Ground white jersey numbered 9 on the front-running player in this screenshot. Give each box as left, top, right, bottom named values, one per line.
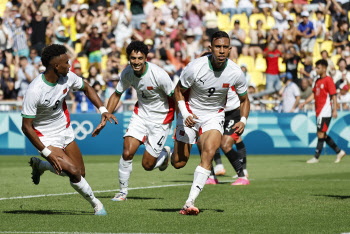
left=180, top=55, right=247, bottom=117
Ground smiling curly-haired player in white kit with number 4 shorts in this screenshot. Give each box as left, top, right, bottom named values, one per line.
left=92, top=41, right=175, bottom=201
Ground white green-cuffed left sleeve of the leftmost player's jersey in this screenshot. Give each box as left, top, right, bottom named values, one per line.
left=21, top=89, right=40, bottom=119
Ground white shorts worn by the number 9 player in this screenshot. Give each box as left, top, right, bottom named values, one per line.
left=176, top=111, right=225, bottom=145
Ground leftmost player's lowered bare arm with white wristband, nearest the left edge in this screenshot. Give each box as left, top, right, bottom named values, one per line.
left=22, top=118, right=62, bottom=175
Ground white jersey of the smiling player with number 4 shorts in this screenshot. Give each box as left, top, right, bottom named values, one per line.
left=115, top=62, right=175, bottom=124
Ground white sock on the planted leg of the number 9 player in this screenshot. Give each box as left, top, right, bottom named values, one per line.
left=186, top=166, right=210, bottom=203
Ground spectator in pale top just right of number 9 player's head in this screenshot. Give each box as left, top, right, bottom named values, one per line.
left=228, top=20, right=246, bottom=61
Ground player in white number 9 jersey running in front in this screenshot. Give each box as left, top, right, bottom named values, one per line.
left=171, top=31, right=250, bottom=215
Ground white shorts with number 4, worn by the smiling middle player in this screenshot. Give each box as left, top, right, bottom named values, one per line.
left=124, top=113, right=171, bottom=158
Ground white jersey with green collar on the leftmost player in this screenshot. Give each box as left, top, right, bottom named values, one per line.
left=22, top=71, right=84, bottom=137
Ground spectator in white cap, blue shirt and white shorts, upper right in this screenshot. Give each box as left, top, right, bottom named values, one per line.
left=298, top=11, right=316, bottom=55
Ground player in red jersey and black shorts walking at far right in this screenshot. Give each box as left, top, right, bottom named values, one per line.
left=299, top=59, right=345, bottom=163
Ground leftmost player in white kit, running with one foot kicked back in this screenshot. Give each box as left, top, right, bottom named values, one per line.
left=22, top=44, right=117, bottom=215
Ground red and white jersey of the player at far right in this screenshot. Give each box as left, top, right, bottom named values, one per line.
left=312, top=76, right=337, bottom=117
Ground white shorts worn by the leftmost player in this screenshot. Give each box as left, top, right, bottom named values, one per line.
left=39, top=125, right=75, bottom=149
